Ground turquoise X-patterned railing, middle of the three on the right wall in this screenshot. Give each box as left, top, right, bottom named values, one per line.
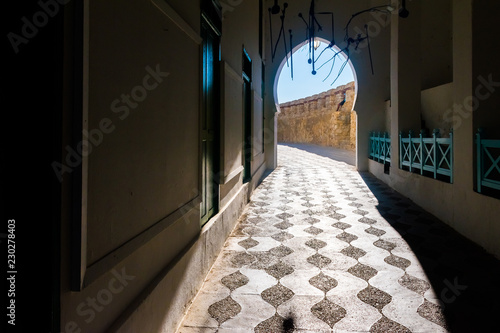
left=399, top=130, right=453, bottom=183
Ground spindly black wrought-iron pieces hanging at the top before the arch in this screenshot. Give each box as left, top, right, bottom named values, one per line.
left=269, top=0, right=409, bottom=85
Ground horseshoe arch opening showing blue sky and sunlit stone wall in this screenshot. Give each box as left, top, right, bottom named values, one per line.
left=274, top=38, right=358, bottom=164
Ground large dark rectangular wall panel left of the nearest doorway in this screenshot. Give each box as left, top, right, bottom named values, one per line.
left=87, top=0, right=201, bottom=264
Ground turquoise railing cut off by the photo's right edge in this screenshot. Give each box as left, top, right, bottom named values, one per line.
left=476, top=129, right=500, bottom=193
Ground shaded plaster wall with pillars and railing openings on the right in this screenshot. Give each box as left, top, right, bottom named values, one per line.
left=368, top=0, right=500, bottom=257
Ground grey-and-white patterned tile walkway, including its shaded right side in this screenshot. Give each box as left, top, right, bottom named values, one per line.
left=178, top=146, right=500, bottom=333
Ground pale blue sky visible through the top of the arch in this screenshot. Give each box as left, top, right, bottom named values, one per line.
left=277, top=42, right=354, bottom=104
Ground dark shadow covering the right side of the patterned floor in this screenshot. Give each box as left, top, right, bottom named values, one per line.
left=360, top=172, right=500, bottom=333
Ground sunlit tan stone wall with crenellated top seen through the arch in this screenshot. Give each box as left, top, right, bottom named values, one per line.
left=278, top=82, right=356, bottom=151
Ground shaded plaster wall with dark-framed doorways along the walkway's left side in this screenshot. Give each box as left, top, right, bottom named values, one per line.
left=60, top=0, right=265, bottom=333
